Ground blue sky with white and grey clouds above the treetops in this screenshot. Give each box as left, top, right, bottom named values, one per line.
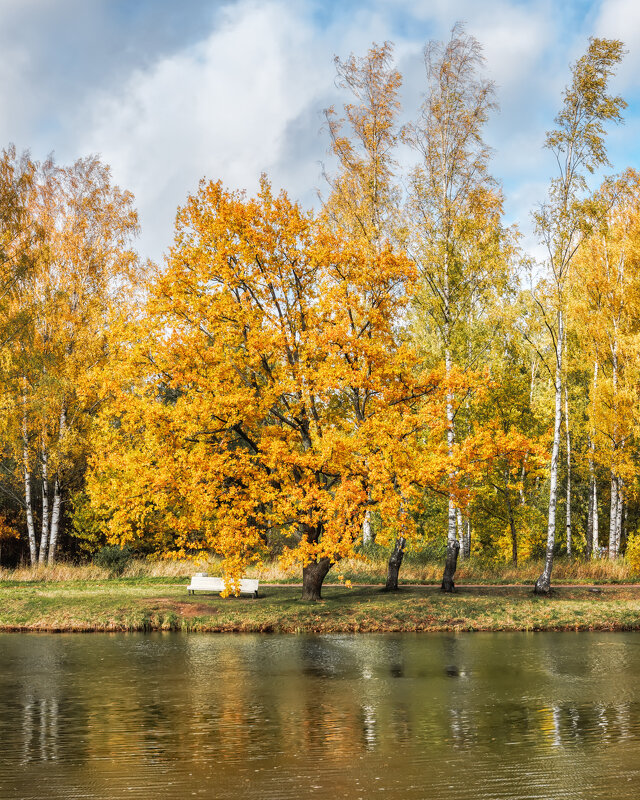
left=0, top=0, right=640, bottom=260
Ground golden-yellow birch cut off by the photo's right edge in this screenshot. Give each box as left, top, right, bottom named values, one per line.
left=570, top=169, right=640, bottom=558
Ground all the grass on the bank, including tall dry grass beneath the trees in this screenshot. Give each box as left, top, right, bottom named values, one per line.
left=0, top=558, right=640, bottom=633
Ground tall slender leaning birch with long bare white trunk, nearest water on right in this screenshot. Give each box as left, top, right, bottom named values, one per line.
left=534, top=38, right=625, bottom=594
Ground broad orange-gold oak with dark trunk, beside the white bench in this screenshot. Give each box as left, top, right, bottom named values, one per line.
left=90, top=179, right=442, bottom=600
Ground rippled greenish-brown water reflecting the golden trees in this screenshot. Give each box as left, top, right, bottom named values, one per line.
left=0, top=633, right=640, bottom=800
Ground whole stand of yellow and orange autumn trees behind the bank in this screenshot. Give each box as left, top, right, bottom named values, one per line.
left=0, top=24, right=640, bottom=600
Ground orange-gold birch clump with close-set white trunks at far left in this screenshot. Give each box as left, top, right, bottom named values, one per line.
left=3, top=158, right=137, bottom=564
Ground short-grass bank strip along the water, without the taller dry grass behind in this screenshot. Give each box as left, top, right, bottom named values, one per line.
left=0, top=578, right=640, bottom=633
